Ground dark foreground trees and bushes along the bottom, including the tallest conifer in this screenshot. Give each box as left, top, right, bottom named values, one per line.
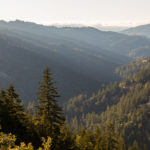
left=0, top=68, right=138, bottom=150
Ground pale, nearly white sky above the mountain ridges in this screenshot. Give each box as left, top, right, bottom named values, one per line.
left=0, top=0, right=150, bottom=25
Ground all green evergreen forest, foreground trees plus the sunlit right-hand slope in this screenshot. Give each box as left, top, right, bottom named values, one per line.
left=0, top=57, right=150, bottom=150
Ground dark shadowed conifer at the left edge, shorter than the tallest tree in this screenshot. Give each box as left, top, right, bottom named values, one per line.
left=0, top=84, right=30, bottom=142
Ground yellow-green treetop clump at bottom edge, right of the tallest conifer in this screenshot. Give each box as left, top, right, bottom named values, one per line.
left=76, top=123, right=125, bottom=150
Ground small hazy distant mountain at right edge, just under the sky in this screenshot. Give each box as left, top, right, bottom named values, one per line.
left=121, top=24, right=150, bottom=38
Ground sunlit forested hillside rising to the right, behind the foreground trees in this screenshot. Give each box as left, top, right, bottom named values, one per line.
left=64, top=57, right=150, bottom=150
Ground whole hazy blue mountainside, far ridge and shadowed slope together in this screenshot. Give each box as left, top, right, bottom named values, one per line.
left=0, top=20, right=150, bottom=103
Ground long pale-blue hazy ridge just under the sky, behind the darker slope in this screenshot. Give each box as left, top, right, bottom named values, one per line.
left=0, top=20, right=150, bottom=55
